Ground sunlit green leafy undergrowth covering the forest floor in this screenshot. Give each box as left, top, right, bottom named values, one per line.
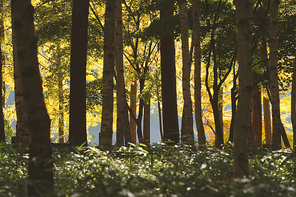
left=0, top=144, right=296, bottom=197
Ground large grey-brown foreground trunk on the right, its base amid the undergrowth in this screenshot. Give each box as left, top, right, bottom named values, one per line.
left=234, top=0, right=253, bottom=178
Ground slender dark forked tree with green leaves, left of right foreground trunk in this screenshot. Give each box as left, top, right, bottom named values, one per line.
left=202, top=0, right=237, bottom=148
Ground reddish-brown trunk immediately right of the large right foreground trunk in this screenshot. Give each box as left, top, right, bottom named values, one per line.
left=252, top=84, right=262, bottom=148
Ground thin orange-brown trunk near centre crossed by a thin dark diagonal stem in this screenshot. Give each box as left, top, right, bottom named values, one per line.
left=130, top=80, right=137, bottom=144
